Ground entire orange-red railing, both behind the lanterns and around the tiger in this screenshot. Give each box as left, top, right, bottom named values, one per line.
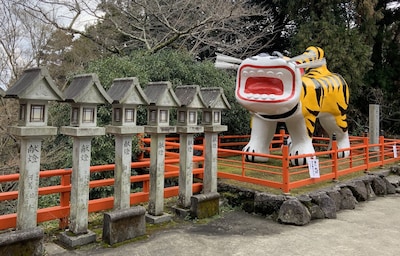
left=0, top=132, right=400, bottom=230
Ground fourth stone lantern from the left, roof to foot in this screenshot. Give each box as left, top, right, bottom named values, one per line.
left=144, top=82, right=181, bottom=223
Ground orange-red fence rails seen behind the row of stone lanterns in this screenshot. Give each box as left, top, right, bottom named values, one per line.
left=0, top=157, right=203, bottom=230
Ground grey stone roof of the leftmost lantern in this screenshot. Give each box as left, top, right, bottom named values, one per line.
left=5, top=67, right=64, bottom=101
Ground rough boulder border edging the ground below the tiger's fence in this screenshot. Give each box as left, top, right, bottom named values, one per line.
left=218, top=165, right=400, bottom=226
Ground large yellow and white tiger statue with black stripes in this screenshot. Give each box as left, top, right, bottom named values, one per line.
left=215, top=46, right=350, bottom=165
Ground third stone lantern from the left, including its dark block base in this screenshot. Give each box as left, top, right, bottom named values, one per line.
left=103, top=77, right=149, bottom=245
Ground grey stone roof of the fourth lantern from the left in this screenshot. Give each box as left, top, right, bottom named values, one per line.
left=144, top=81, right=181, bottom=107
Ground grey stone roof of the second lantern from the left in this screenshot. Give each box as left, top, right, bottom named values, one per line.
left=64, top=73, right=112, bottom=104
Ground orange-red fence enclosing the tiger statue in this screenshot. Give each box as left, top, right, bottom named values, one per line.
left=218, top=135, right=400, bottom=193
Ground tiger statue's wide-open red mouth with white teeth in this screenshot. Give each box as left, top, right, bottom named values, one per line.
left=236, top=65, right=295, bottom=103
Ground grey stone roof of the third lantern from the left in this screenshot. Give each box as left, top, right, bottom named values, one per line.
left=107, top=77, right=150, bottom=105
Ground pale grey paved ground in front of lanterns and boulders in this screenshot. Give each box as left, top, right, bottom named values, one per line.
left=46, top=194, right=400, bottom=256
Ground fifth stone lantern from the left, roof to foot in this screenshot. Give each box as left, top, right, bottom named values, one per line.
left=175, top=85, right=206, bottom=209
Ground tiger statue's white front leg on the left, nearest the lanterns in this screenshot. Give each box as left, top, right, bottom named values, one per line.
left=243, top=115, right=277, bottom=162
